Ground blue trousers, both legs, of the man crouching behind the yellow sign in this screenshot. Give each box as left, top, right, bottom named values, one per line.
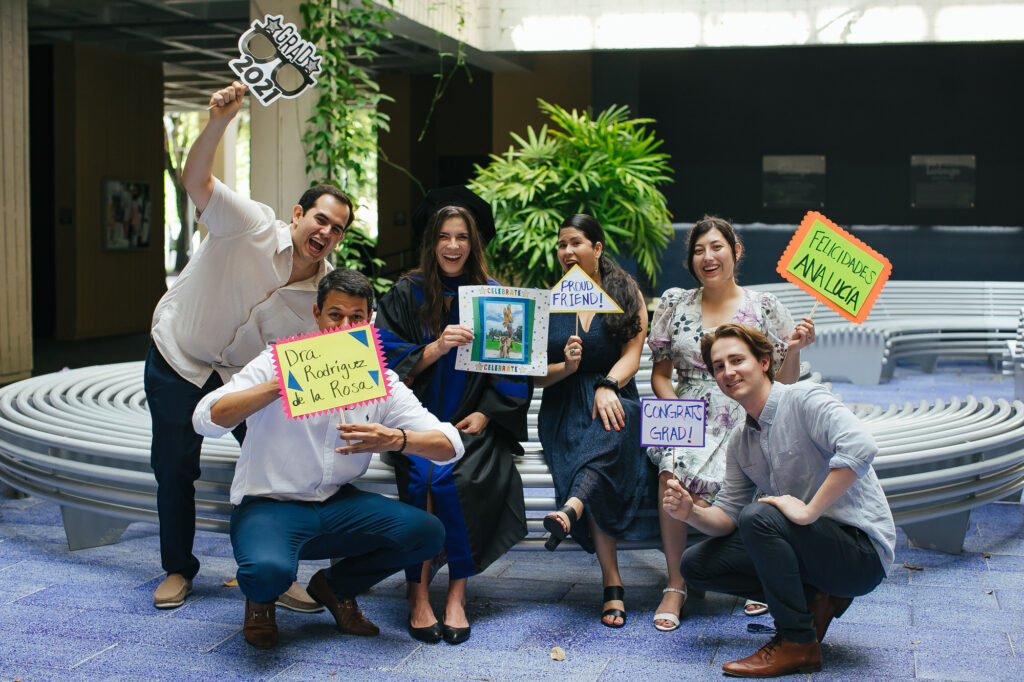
left=231, top=484, right=444, bottom=603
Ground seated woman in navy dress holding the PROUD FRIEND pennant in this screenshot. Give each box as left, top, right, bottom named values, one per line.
left=537, top=214, right=657, bottom=628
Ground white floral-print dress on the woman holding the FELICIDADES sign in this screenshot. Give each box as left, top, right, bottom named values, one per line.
left=647, top=288, right=794, bottom=503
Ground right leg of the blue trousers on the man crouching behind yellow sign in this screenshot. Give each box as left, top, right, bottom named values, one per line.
left=301, top=485, right=444, bottom=599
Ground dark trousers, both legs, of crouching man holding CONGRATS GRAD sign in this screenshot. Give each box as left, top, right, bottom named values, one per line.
left=682, top=502, right=885, bottom=642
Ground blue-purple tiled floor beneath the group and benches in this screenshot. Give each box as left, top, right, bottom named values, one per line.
left=0, top=356, right=1024, bottom=682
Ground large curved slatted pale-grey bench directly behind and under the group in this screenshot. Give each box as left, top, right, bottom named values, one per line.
left=0, top=360, right=1024, bottom=552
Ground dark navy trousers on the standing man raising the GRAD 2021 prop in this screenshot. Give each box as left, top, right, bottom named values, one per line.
left=144, top=343, right=246, bottom=580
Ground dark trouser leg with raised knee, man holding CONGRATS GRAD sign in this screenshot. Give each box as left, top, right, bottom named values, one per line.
left=738, top=502, right=885, bottom=642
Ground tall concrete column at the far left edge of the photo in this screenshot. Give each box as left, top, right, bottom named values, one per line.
left=0, top=0, right=32, bottom=384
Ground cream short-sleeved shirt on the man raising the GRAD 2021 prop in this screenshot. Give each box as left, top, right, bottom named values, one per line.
left=152, top=178, right=333, bottom=386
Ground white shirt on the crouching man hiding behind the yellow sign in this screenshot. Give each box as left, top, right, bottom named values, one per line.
left=193, top=348, right=466, bottom=505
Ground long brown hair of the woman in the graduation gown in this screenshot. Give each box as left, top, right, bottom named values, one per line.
left=407, top=206, right=490, bottom=338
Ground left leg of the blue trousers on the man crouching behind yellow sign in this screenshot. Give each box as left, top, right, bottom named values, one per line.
left=230, top=497, right=321, bottom=603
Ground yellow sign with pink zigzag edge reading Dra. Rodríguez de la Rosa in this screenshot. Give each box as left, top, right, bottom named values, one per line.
left=273, top=324, right=391, bottom=419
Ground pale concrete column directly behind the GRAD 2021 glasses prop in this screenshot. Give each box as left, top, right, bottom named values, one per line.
left=249, top=0, right=316, bottom=216
